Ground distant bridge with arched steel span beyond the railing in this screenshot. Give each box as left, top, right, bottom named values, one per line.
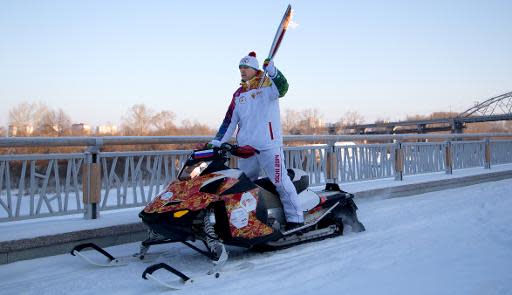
left=340, top=91, right=512, bottom=134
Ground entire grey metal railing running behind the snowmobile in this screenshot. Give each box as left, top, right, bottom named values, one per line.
left=0, top=134, right=512, bottom=222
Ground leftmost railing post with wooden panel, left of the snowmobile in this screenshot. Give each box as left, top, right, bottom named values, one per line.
left=82, top=147, right=101, bottom=219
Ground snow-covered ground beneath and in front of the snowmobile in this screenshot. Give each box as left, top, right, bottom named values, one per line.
left=0, top=179, right=512, bottom=295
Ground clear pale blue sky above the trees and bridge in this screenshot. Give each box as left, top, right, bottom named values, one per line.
left=0, top=0, right=512, bottom=128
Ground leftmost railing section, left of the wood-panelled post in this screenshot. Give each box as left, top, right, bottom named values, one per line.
left=0, top=154, right=86, bottom=221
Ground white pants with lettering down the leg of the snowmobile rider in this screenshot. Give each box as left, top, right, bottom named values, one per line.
left=238, top=148, right=304, bottom=222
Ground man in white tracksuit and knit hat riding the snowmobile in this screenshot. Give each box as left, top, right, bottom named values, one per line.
left=211, top=52, right=304, bottom=230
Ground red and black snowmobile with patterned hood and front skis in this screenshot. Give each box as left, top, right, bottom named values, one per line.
left=71, top=143, right=365, bottom=289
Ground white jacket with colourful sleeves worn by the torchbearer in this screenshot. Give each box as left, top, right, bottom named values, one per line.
left=215, top=70, right=288, bottom=150
